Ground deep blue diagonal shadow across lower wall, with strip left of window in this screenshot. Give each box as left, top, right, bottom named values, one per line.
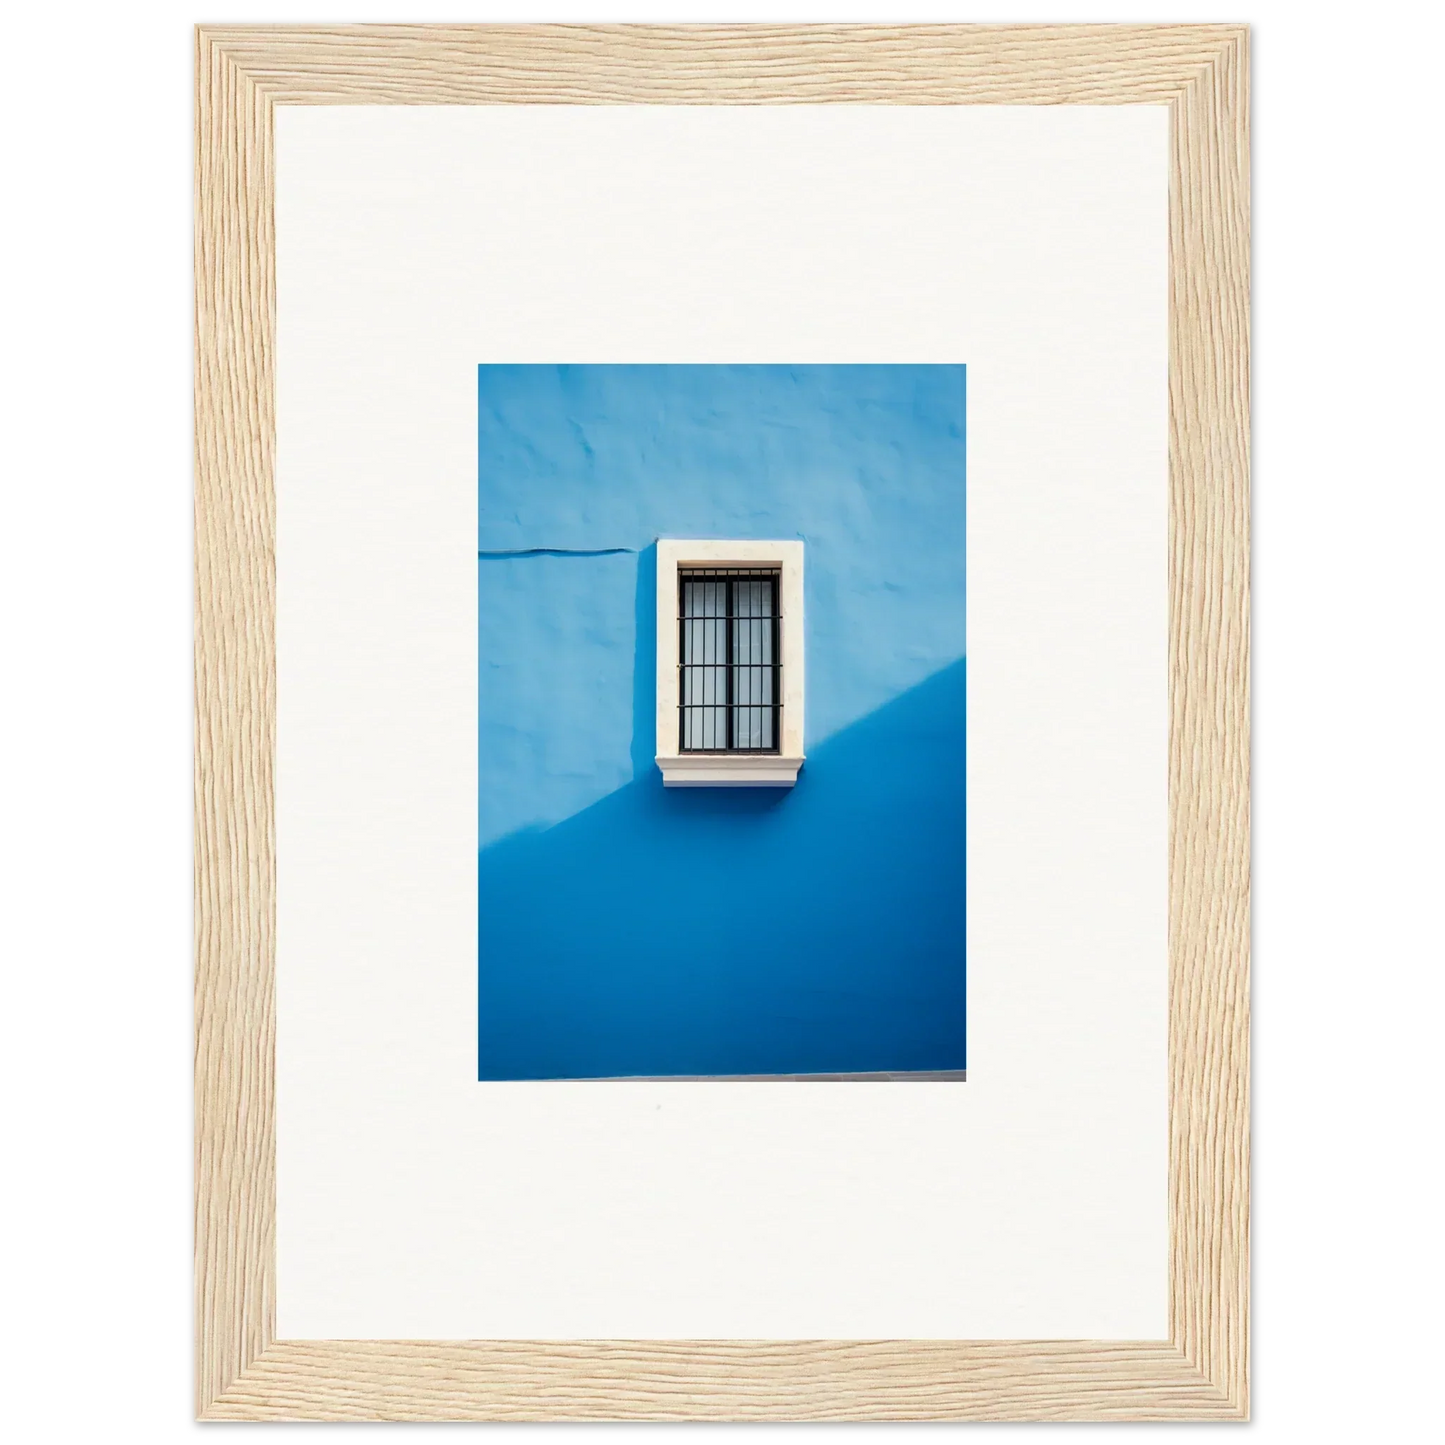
left=478, top=653, right=967, bottom=1079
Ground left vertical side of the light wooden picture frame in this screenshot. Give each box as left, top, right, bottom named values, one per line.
left=194, top=22, right=276, bottom=1421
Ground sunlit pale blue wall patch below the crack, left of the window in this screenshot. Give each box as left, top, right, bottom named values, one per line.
left=477, top=553, right=637, bottom=847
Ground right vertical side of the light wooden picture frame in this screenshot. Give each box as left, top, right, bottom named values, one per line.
left=1169, top=29, right=1250, bottom=1415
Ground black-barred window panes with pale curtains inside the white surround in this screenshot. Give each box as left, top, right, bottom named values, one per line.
left=678, top=566, right=783, bottom=753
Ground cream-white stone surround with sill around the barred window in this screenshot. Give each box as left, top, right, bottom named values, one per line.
left=657, top=539, right=803, bottom=788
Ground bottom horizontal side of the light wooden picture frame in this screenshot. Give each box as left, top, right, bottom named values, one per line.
left=208, top=1340, right=1237, bottom=1420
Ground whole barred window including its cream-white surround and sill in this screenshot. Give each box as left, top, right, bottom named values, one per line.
left=657, top=539, right=803, bottom=788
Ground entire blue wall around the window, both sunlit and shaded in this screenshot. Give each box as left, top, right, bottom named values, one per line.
left=478, top=366, right=965, bottom=1079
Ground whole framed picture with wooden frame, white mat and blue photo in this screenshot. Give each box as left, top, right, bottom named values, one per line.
left=188, top=17, right=1259, bottom=1435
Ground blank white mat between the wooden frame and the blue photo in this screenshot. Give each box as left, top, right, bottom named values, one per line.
left=276, top=105, right=1168, bottom=1340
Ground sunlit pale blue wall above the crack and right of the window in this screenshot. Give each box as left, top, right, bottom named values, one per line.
left=477, top=366, right=964, bottom=746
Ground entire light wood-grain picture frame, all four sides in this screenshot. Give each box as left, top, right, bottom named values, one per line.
left=194, top=23, right=1250, bottom=1420
